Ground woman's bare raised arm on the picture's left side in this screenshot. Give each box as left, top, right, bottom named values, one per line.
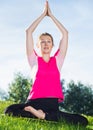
left=26, top=3, right=47, bottom=56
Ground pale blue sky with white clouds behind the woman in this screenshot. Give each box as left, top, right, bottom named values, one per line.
left=0, top=0, right=93, bottom=91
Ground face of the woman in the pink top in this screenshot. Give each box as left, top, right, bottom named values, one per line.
left=39, top=35, right=53, bottom=54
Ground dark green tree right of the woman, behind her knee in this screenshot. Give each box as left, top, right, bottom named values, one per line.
left=63, top=81, right=93, bottom=115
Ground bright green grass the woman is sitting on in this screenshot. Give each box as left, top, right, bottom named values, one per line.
left=0, top=101, right=93, bottom=130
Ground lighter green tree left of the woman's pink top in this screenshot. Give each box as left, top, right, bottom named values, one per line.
left=8, top=73, right=32, bottom=103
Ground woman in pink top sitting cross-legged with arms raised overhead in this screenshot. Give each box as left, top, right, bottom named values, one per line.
left=5, top=1, right=87, bottom=125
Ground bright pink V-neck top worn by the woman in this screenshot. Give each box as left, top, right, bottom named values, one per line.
left=28, top=51, right=64, bottom=101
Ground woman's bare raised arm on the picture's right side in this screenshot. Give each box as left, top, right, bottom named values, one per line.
left=47, top=1, right=68, bottom=57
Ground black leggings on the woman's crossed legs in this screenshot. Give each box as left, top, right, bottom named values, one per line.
left=5, top=98, right=88, bottom=126
